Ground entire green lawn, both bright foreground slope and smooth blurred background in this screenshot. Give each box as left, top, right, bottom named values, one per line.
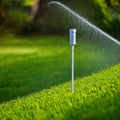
left=0, top=36, right=120, bottom=120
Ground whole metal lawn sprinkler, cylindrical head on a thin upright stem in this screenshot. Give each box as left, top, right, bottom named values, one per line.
left=69, top=29, right=76, bottom=93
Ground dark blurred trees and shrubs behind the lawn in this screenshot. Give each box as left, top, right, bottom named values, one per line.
left=0, top=0, right=120, bottom=39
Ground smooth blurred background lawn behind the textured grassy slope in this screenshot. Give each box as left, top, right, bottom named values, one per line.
left=0, top=36, right=119, bottom=102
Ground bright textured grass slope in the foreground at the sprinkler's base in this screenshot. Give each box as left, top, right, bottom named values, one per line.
left=0, top=64, right=120, bottom=120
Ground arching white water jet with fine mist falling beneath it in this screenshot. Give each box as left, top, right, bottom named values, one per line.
left=49, top=1, right=120, bottom=85
